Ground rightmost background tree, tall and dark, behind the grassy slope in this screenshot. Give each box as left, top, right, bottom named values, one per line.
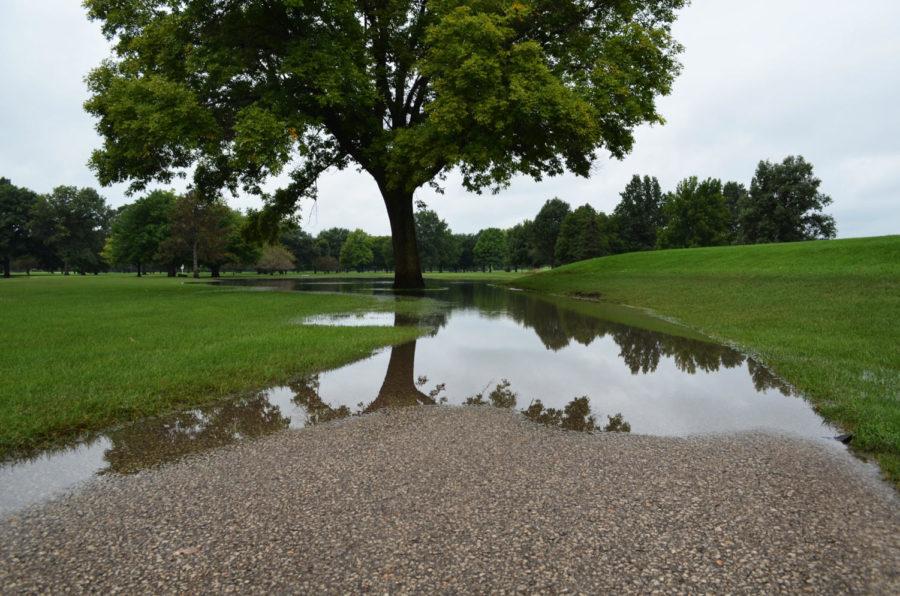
left=740, top=156, right=837, bottom=243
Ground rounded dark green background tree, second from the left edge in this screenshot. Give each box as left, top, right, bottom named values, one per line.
left=31, top=186, right=111, bottom=275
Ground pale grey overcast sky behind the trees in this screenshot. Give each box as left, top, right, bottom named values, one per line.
left=0, top=0, right=900, bottom=237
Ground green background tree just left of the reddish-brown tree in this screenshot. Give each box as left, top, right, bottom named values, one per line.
left=106, top=190, right=176, bottom=277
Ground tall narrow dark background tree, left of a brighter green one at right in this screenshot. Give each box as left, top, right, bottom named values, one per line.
left=613, top=175, right=663, bottom=252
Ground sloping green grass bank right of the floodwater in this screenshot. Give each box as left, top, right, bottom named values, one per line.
left=513, top=236, right=900, bottom=482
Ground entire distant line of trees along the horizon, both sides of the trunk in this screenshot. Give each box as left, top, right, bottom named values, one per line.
left=0, top=156, right=836, bottom=276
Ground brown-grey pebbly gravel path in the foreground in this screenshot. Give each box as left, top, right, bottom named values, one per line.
left=0, top=407, right=900, bottom=594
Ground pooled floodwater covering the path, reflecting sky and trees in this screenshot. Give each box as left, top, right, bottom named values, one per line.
left=0, top=280, right=837, bottom=515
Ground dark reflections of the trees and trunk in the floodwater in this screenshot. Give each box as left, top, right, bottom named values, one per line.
left=91, top=282, right=792, bottom=473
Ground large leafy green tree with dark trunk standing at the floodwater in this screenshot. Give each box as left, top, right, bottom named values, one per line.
left=85, top=0, right=684, bottom=287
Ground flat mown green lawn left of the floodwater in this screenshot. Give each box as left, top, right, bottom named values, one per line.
left=0, top=275, right=419, bottom=455
